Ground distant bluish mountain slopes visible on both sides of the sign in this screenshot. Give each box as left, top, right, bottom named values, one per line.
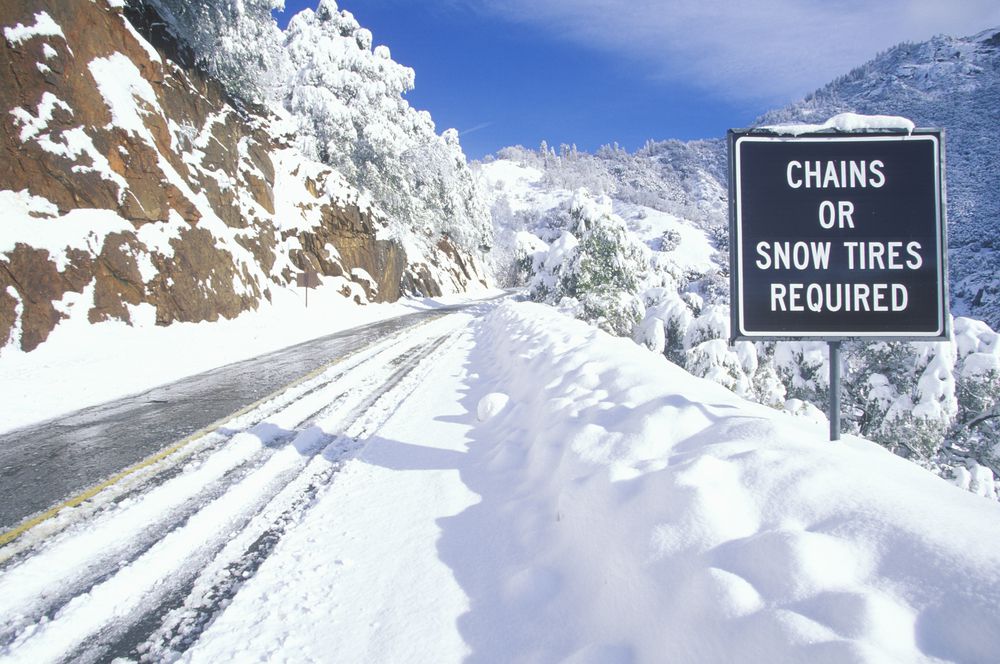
left=497, top=29, right=1000, bottom=328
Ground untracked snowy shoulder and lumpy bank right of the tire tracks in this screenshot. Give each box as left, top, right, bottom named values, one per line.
left=150, top=303, right=1000, bottom=664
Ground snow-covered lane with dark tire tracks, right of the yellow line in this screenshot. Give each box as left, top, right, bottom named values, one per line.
left=0, top=314, right=482, bottom=662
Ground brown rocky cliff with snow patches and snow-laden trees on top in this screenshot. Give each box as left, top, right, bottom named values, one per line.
left=0, top=0, right=490, bottom=354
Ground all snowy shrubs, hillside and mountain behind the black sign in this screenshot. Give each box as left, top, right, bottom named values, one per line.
left=481, top=30, right=1000, bottom=504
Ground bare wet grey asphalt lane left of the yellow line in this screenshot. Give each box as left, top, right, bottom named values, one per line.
left=0, top=305, right=469, bottom=532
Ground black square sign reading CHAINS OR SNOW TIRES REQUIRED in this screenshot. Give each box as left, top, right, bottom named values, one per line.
left=729, top=131, right=948, bottom=339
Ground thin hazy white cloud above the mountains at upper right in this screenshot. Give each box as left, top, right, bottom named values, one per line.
left=464, top=0, right=1000, bottom=102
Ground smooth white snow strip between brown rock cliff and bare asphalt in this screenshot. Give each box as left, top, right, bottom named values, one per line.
left=0, top=287, right=499, bottom=433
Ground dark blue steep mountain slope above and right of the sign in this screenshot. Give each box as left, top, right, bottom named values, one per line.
left=758, top=27, right=1000, bottom=328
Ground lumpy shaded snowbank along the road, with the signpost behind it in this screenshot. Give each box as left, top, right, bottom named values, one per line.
left=472, top=304, right=1000, bottom=663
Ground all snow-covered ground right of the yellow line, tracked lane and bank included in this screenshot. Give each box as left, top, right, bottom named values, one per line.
left=0, top=303, right=1000, bottom=664
